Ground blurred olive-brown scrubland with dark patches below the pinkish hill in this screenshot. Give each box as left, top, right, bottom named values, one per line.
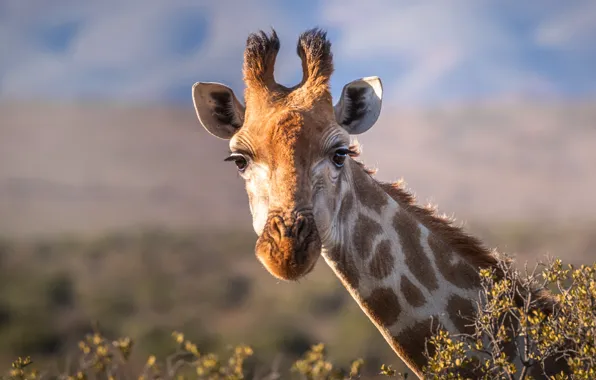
left=0, top=224, right=596, bottom=374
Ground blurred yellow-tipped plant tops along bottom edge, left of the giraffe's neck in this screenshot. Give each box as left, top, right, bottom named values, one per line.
left=0, top=331, right=408, bottom=380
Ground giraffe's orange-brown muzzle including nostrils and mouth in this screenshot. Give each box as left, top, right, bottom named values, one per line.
left=255, top=214, right=321, bottom=281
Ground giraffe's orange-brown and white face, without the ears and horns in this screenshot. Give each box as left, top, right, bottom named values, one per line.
left=230, top=108, right=349, bottom=280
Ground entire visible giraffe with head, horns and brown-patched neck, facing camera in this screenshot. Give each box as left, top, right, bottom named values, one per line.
left=192, top=28, right=568, bottom=377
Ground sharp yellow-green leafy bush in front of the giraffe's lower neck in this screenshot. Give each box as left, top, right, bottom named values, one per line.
left=426, top=260, right=596, bottom=379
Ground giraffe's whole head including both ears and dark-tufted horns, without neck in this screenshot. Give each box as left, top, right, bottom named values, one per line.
left=192, top=29, right=382, bottom=280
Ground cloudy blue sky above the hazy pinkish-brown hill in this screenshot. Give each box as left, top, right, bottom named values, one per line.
left=0, top=0, right=596, bottom=105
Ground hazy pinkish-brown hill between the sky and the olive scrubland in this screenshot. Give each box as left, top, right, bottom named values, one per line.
left=0, top=102, right=596, bottom=235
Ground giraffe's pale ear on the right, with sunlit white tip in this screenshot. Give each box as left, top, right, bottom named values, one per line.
left=335, top=77, right=383, bottom=135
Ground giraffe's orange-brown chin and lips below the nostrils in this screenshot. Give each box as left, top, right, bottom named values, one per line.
left=255, top=234, right=321, bottom=281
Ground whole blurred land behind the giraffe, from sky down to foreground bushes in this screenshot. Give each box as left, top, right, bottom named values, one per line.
left=0, top=103, right=596, bottom=378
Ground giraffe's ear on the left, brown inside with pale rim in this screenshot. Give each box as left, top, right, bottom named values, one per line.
left=192, top=82, right=244, bottom=140
